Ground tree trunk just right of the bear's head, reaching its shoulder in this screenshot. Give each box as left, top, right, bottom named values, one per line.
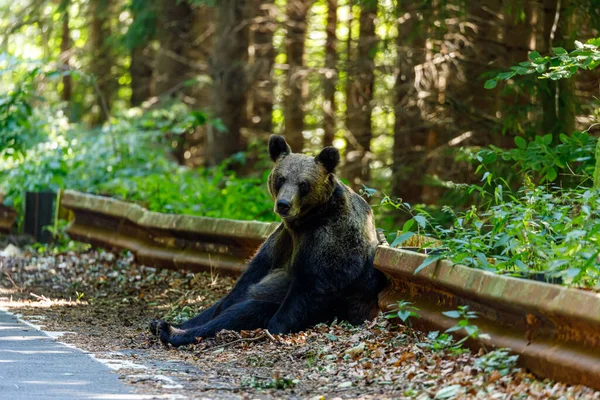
left=346, top=0, right=377, bottom=189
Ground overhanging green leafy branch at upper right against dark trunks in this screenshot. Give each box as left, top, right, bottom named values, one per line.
left=484, top=38, right=600, bottom=89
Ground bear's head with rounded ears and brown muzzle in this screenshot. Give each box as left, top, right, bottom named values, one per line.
left=269, top=135, right=340, bottom=221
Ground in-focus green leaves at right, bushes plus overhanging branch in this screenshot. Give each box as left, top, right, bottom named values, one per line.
left=376, top=39, right=600, bottom=290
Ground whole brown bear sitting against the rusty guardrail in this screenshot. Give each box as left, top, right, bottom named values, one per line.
left=150, top=135, right=385, bottom=346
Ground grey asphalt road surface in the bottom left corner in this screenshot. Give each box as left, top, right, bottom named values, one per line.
left=0, top=310, right=153, bottom=400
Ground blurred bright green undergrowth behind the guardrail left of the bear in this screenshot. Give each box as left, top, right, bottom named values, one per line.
left=0, top=100, right=274, bottom=221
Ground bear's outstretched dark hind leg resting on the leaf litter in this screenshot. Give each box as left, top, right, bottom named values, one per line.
left=157, top=300, right=279, bottom=347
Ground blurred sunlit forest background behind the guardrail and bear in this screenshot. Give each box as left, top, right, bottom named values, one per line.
left=0, top=0, right=600, bottom=230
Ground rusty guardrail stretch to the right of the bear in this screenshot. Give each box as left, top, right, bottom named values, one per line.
left=375, top=247, right=600, bottom=389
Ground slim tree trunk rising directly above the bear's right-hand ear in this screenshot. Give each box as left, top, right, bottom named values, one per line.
left=323, top=0, right=338, bottom=147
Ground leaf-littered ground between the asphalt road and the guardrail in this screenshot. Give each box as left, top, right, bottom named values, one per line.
left=0, top=242, right=600, bottom=399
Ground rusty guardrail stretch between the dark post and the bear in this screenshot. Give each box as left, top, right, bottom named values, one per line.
left=60, top=190, right=278, bottom=274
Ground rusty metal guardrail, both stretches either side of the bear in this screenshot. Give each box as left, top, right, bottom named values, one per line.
left=62, top=191, right=600, bottom=389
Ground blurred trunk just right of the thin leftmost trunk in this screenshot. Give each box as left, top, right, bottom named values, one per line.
left=89, top=0, right=115, bottom=125
